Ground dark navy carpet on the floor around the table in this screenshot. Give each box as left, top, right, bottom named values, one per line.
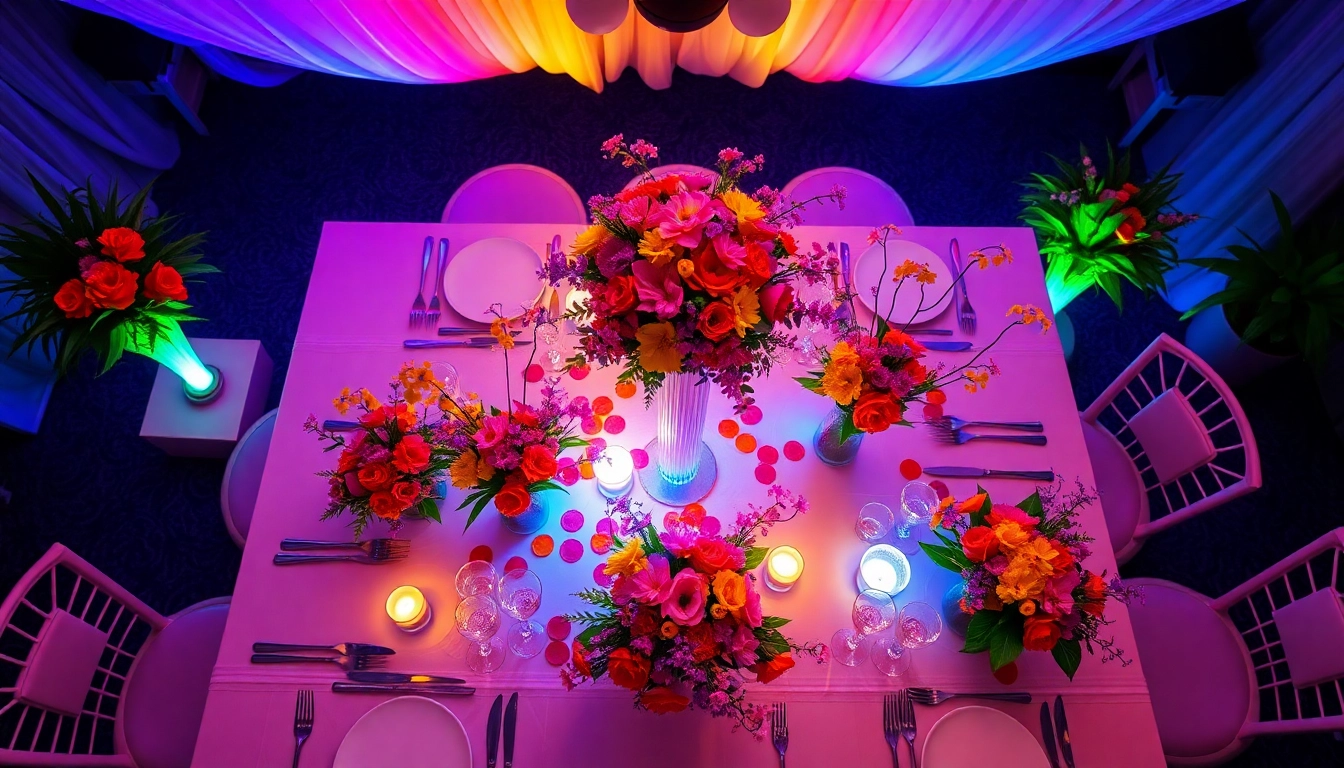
left=0, top=61, right=1344, bottom=768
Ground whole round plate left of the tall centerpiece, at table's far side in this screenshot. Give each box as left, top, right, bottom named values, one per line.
left=444, top=237, right=543, bottom=323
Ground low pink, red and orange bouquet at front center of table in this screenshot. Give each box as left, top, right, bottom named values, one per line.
left=560, top=486, right=828, bottom=737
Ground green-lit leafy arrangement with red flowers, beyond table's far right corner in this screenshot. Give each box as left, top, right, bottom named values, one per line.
left=1020, top=147, right=1199, bottom=312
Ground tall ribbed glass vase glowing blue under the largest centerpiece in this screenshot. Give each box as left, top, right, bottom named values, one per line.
left=640, top=374, right=719, bottom=507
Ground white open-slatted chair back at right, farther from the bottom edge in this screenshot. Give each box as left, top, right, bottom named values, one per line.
left=1082, top=334, right=1261, bottom=538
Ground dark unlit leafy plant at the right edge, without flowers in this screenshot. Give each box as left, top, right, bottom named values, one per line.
left=1181, top=192, right=1344, bottom=369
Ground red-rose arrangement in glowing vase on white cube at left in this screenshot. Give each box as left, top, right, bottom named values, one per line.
left=0, top=174, right=220, bottom=402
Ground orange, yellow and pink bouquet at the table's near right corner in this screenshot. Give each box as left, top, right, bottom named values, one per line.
left=919, top=484, right=1138, bottom=679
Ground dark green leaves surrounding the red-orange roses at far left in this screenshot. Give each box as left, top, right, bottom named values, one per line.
left=0, top=174, right=218, bottom=374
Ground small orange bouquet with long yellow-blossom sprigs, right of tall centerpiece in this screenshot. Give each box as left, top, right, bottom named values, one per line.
left=794, top=225, right=1051, bottom=441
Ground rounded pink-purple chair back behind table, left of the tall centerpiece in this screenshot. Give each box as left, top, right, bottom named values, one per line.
left=442, top=163, right=587, bottom=225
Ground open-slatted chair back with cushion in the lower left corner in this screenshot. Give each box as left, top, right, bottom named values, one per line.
left=0, top=543, right=168, bottom=768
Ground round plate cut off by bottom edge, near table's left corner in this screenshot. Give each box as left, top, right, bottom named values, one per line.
left=332, top=695, right=472, bottom=768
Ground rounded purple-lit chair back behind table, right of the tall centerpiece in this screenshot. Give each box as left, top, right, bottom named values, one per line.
left=784, top=165, right=915, bottom=227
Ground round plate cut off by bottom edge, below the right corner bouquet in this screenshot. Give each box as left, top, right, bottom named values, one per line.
left=919, top=706, right=1050, bottom=768
